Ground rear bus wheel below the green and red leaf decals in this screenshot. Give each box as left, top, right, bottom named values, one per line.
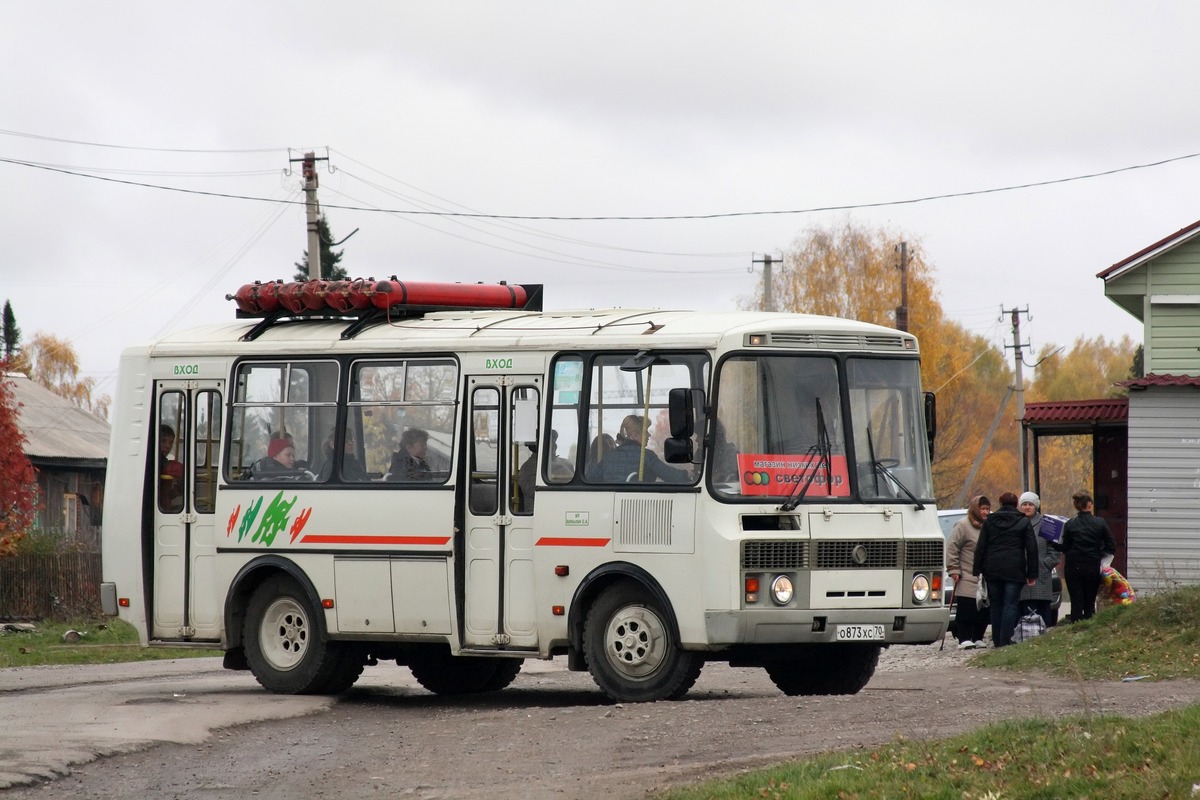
left=242, top=575, right=348, bottom=694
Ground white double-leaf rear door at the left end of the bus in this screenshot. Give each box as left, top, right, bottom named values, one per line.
left=149, top=380, right=223, bottom=642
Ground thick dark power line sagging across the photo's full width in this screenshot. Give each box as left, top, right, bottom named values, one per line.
left=0, top=152, right=1200, bottom=222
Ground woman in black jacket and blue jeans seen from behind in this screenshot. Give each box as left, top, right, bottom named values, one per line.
left=971, top=492, right=1038, bottom=648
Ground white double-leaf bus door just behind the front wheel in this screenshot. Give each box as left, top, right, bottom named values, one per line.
left=462, top=375, right=541, bottom=650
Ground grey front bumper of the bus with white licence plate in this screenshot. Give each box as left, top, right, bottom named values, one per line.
left=704, top=606, right=950, bottom=648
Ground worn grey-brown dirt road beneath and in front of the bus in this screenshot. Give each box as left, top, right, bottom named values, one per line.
left=0, top=643, right=1200, bottom=800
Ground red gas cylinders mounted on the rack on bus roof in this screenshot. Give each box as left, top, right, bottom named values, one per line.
left=226, top=276, right=542, bottom=342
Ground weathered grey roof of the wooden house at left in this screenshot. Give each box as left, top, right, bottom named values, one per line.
left=4, top=373, right=112, bottom=467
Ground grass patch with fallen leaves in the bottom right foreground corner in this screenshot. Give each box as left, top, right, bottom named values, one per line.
left=660, top=706, right=1200, bottom=800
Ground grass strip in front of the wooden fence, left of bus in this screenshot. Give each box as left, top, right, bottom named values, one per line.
left=0, top=616, right=221, bottom=668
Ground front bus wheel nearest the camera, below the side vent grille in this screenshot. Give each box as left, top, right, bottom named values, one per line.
left=583, top=583, right=703, bottom=703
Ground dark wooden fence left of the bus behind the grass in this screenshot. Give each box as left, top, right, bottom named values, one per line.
left=0, top=553, right=102, bottom=620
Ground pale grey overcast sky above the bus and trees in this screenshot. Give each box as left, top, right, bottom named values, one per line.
left=0, top=0, right=1200, bottom=393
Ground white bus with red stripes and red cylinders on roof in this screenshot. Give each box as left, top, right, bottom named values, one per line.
left=102, top=279, right=948, bottom=702
